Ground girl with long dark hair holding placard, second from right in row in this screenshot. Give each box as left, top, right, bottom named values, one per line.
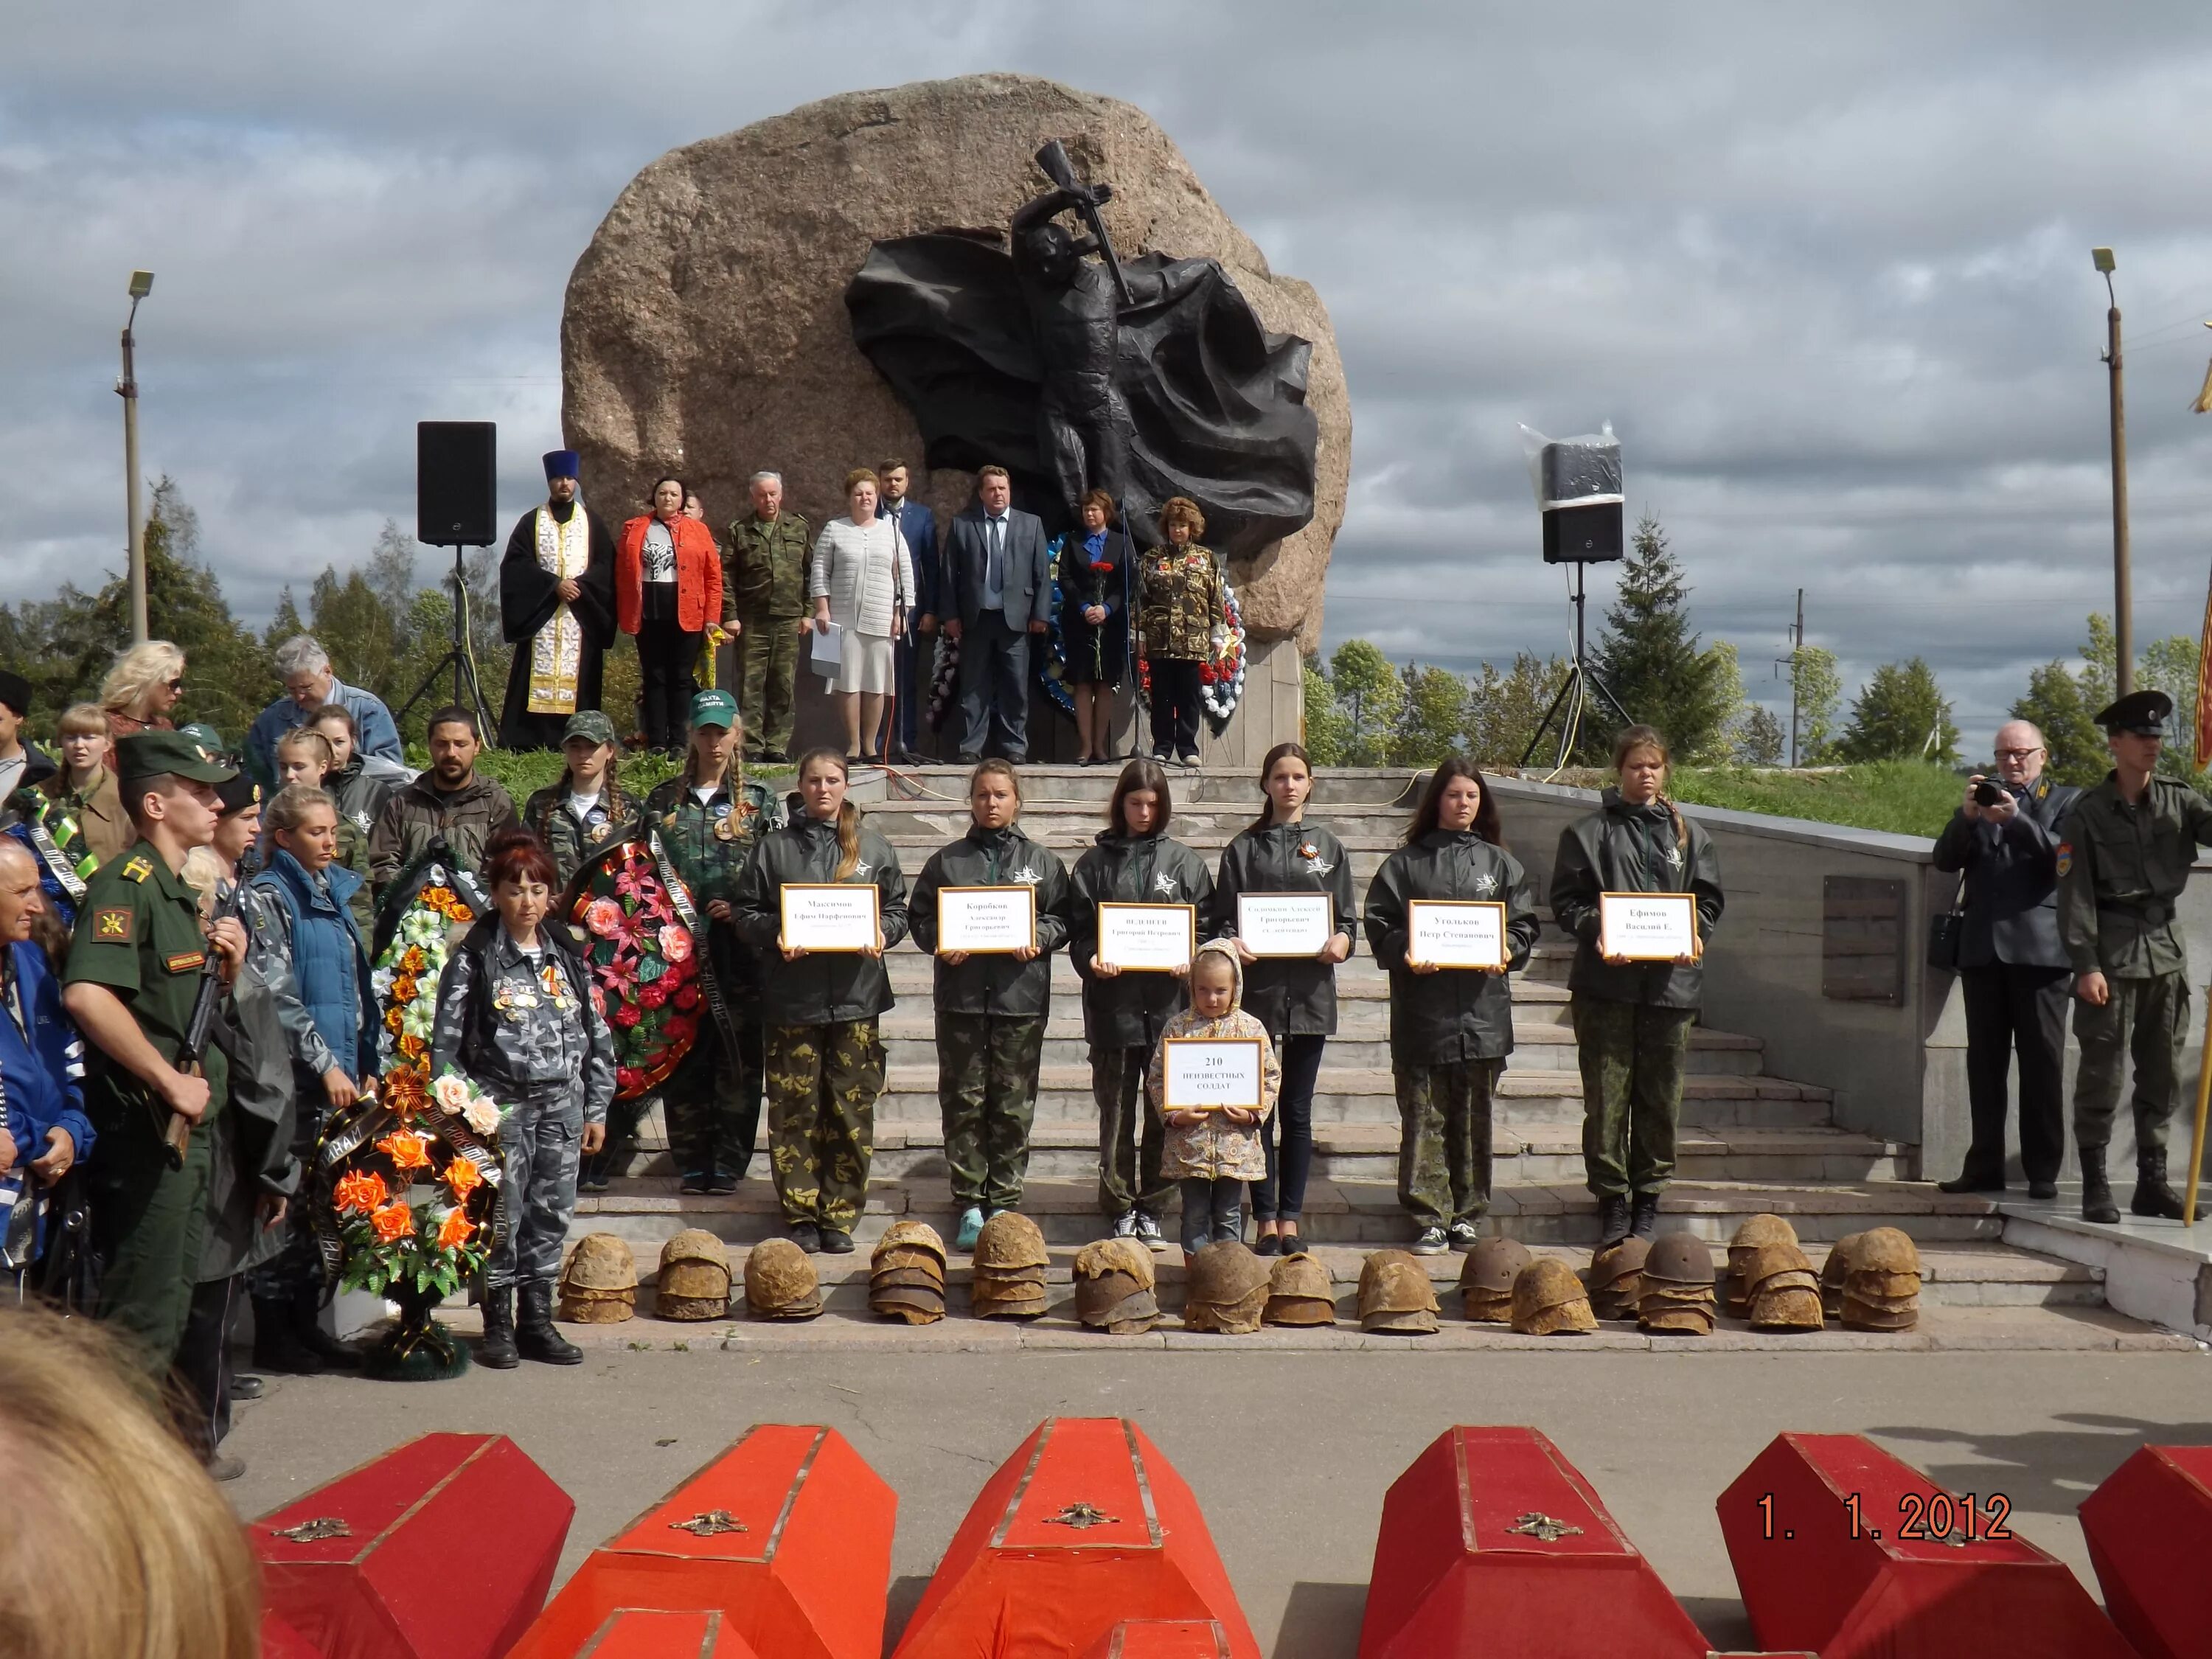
left=1365, top=754, right=1542, bottom=1256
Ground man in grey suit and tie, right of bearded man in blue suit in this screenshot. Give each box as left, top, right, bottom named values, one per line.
left=940, top=467, right=1053, bottom=763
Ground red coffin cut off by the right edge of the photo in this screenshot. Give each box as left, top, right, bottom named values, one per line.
left=2081, top=1447, right=2212, bottom=1659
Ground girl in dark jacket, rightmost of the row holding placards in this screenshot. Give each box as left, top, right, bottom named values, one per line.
left=1551, top=726, right=1725, bottom=1245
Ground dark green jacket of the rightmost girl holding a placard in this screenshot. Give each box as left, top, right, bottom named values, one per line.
left=1551, top=790, right=1725, bottom=1009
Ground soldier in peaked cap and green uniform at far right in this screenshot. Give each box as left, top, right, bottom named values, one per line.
left=2059, top=690, right=2212, bottom=1221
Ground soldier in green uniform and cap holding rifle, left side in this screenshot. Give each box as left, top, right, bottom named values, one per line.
left=62, top=732, right=246, bottom=1378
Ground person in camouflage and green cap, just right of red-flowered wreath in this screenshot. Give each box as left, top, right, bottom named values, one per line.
left=644, top=690, right=783, bottom=1192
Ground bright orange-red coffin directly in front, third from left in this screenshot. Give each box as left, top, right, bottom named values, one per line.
left=894, top=1418, right=1259, bottom=1659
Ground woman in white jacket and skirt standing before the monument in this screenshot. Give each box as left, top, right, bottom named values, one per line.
left=807, top=467, right=914, bottom=765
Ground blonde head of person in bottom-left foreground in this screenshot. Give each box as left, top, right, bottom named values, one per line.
left=0, top=1307, right=261, bottom=1659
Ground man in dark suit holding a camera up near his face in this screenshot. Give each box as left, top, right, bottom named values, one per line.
left=1935, top=721, right=2081, bottom=1199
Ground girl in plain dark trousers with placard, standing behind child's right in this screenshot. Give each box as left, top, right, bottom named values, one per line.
left=1214, top=743, right=1358, bottom=1256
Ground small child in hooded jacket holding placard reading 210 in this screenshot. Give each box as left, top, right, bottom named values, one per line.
left=1146, top=940, right=1283, bottom=1259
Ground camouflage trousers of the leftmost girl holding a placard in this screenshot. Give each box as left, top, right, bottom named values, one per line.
left=768, top=1020, right=883, bottom=1232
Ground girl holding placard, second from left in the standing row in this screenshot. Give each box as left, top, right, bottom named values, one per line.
left=911, top=761, right=1068, bottom=1250
